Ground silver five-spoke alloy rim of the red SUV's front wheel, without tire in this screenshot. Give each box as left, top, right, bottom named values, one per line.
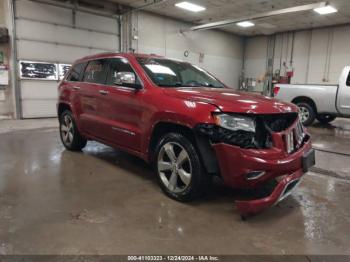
left=157, top=142, right=192, bottom=193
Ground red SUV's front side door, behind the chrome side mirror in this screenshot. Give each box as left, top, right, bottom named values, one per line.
left=102, top=58, right=145, bottom=151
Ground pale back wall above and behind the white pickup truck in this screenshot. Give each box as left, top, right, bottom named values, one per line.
left=245, top=26, right=350, bottom=84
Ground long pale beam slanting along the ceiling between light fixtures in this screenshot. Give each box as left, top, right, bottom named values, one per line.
left=189, top=2, right=327, bottom=32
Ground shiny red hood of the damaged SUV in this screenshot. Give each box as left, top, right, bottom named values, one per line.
left=164, top=87, right=298, bottom=114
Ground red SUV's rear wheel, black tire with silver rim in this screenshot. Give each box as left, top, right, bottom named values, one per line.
left=59, top=110, right=87, bottom=151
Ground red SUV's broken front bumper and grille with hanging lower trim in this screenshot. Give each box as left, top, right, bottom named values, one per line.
left=197, top=113, right=315, bottom=216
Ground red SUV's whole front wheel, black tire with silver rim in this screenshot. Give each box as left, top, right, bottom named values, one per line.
left=153, top=133, right=210, bottom=202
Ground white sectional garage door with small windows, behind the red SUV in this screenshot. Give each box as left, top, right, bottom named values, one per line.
left=15, top=0, right=119, bottom=118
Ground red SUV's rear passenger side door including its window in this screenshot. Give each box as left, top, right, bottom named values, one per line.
left=79, top=59, right=107, bottom=139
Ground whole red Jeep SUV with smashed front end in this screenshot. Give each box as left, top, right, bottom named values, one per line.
left=58, top=53, right=315, bottom=215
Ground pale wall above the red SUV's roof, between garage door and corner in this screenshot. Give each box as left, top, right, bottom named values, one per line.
left=132, top=12, right=243, bottom=88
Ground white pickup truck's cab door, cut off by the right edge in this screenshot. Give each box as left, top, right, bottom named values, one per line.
left=337, top=66, right=350, bottom=116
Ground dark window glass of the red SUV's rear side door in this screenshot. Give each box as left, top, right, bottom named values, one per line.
left=84, top=59, right=107, bottom=84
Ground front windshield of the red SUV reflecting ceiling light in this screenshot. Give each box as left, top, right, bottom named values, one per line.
left=137, top=57, right=224, bottom=88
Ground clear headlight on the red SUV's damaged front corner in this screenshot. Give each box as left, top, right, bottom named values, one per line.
left=214, top=114, right=255, bottom=132
